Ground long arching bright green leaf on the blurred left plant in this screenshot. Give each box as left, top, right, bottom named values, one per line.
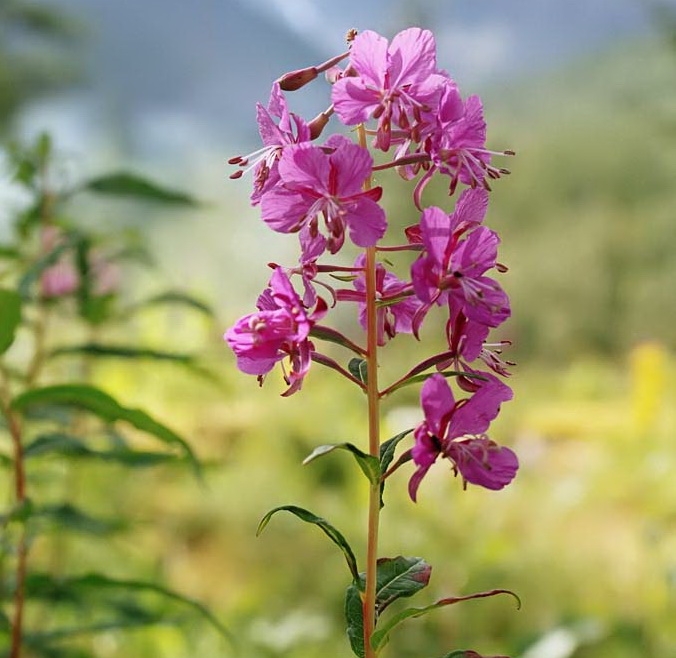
left=12, top=384, right=200, bottom=474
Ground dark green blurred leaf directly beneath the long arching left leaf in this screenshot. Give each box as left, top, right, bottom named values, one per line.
left=24, top=432, right=179, bottom=468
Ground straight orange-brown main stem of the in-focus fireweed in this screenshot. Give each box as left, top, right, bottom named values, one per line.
left=358, top=125, right=380, bottom=658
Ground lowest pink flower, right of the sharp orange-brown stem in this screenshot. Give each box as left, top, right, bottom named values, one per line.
left=408, top=373, right=519, bottom=501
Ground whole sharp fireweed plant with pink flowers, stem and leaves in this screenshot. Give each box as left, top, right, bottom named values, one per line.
left=224, top=27, right=518, bottom=658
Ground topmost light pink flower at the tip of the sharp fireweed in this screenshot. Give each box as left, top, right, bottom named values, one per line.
left=331, top=27, right=444, bottom=151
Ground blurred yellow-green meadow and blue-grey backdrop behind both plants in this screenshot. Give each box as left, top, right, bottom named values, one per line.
left=0, top=0, right=676, bottom=658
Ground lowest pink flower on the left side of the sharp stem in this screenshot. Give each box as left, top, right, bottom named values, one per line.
left=223, top=268, right=327, bottom=395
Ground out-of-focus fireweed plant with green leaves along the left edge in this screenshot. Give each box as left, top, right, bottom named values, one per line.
left=0, top=135, right=227, bottom=658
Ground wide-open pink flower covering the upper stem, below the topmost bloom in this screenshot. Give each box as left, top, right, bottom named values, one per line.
left=261, top=135, right=387, bottom=262
